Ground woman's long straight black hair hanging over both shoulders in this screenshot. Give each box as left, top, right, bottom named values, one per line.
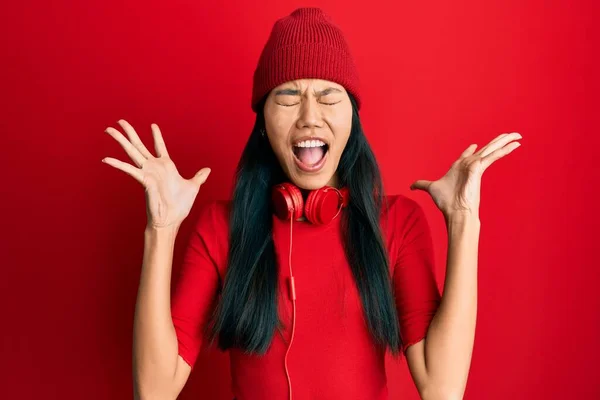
left=209, top=93, right=401, bottom=356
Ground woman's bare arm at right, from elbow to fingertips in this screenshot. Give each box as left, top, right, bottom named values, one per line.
left=406, top=132, right=522, bottom=400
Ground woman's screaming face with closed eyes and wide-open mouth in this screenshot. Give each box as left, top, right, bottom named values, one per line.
left=264, top=79, right=352, bottom=190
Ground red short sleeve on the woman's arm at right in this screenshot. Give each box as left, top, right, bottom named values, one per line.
left=393, top=198, right=441, bottom=354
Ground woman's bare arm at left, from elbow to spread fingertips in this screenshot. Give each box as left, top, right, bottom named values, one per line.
left=102, top=119, right=210, bottom=400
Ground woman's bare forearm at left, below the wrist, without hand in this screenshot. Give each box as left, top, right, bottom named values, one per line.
left=133, top=228, right=178, bottom=398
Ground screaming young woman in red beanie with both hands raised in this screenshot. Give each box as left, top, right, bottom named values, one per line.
left=103, top=8, right=521, bottom=400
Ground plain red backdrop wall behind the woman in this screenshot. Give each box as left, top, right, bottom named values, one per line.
left=0, top=0, right=600, bottom=400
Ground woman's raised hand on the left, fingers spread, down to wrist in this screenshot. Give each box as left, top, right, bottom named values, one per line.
left=102, top=119, right=211, bottom=229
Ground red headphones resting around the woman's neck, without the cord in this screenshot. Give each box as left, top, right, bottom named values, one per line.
left=271, top=182, right=349, bottom=225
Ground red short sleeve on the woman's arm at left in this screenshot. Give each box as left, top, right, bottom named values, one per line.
left=171, top=202, right=219, bottom=368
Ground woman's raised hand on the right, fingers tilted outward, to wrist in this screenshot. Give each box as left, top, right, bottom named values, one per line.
left=410, top=132, right=522, bottom=218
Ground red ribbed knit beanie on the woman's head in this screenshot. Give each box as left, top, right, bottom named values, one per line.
left=252, top=7, right=360, bottom=112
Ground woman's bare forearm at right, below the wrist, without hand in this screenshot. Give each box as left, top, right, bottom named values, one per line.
left=425, top=215, right=480, bottom=399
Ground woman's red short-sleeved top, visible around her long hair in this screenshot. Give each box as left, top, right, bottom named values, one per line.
left=171, top=195, right=441, bottom=400
